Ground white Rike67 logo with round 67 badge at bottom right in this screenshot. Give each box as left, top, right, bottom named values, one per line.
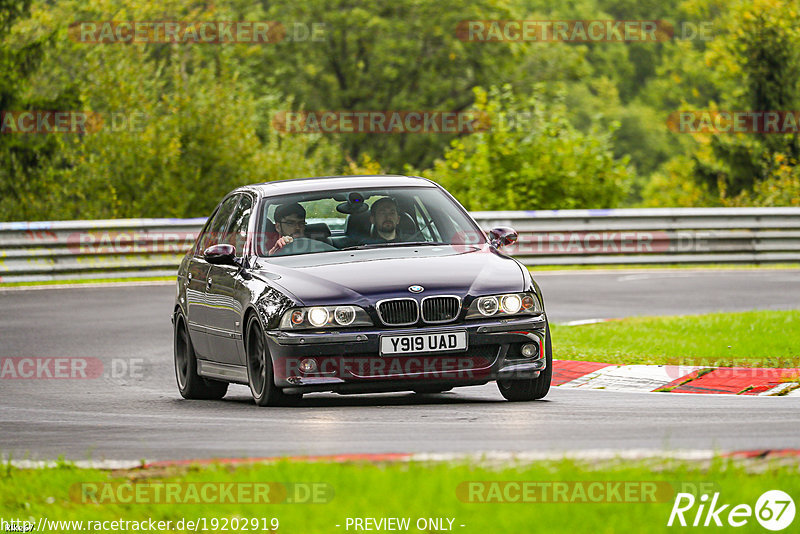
left=667, top=490, right=795, bottom=530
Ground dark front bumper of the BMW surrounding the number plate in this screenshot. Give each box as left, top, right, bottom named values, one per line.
left=267, top=314, right=547, bottom=393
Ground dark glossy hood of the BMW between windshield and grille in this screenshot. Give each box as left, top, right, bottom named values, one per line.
left=255, top=246, right=527, bottom=305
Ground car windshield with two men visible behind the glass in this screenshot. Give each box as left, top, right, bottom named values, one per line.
left=255, top=187, right=485, bottom=257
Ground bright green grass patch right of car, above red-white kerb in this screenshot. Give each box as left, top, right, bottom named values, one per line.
left=552, top=310, right=800, bottom=367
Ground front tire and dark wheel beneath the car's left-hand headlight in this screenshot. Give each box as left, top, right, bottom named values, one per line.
left=245, top=315, right=303, bottom=406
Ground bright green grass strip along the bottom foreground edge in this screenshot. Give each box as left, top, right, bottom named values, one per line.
left=0, top=459, right=800, bottom=534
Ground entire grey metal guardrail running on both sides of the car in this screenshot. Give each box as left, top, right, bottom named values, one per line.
left=0, top=208, right=800, bottom=282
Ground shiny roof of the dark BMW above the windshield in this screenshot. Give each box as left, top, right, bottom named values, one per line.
left=237, top=174, right=438, bottom=196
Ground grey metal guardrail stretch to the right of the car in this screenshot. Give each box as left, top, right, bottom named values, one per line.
left=472, top=208, right=800, bottom=266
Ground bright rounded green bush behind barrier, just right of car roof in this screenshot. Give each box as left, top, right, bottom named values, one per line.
left=424, top=86, right=631, bottom=210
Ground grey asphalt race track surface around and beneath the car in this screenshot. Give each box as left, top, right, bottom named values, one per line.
left=0, top=270, right=800, bottom=460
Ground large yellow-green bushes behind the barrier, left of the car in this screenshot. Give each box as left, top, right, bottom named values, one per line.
left=0, top=0, right=336, bottom=220
